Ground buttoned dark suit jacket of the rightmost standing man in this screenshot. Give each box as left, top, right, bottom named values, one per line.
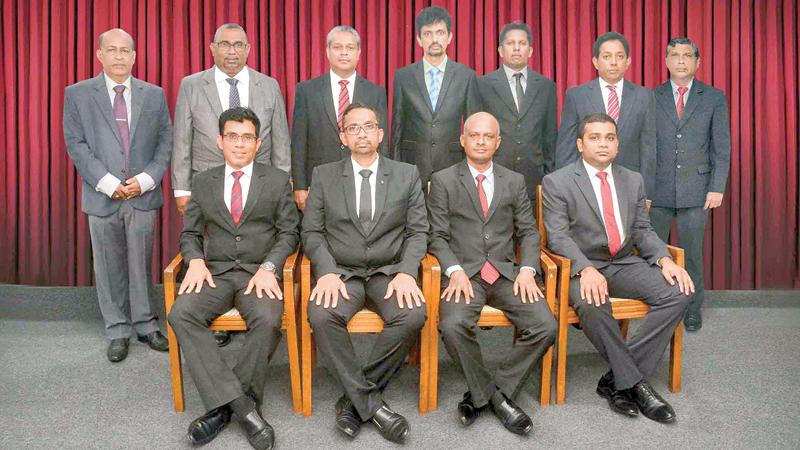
left=651, top=79, right=731, bottom=208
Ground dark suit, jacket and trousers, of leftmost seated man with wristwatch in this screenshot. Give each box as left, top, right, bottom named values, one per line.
left=169, top=163, right=300, bottom=410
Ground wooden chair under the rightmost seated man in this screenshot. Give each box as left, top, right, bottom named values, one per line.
left=536, top=186, right=685, bottom=405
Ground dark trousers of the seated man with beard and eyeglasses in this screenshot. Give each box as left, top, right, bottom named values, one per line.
left=308, top=274, right=426, bottom=420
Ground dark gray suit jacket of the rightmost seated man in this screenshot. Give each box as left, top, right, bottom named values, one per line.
left=542, top=160, right=669, bottom=276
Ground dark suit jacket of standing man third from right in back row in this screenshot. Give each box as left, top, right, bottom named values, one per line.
left=478, top=67, right=558, bottom=199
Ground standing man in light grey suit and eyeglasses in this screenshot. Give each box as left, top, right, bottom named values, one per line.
left=172, top=23, right=291, bottom=346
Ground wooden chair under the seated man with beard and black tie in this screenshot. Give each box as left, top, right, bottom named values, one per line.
left=300, top=255, right=439, bottom=416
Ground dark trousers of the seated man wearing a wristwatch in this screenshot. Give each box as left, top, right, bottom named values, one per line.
left=168, top=269, right=283, bottom=410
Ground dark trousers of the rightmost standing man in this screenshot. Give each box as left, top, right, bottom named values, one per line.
left=650, top=206, right=708, bottom=312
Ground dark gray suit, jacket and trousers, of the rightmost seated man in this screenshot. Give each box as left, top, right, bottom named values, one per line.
left=542, top=160, right=688, bottom=389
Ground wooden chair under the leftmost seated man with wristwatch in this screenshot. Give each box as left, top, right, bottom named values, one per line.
left=164, top=251, right=301, bottom=412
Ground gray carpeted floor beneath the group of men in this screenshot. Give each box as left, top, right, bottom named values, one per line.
left=0, top=286, right=800, bottom=449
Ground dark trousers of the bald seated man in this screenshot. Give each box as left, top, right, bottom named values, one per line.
left=439, top=274, right=557, bottom=407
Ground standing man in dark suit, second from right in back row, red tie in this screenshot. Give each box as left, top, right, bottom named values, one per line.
left=556, top=31, right=656, bottom=197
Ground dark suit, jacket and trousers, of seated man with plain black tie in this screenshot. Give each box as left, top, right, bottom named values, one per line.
left=302, top=157, right=428, bottom=420
